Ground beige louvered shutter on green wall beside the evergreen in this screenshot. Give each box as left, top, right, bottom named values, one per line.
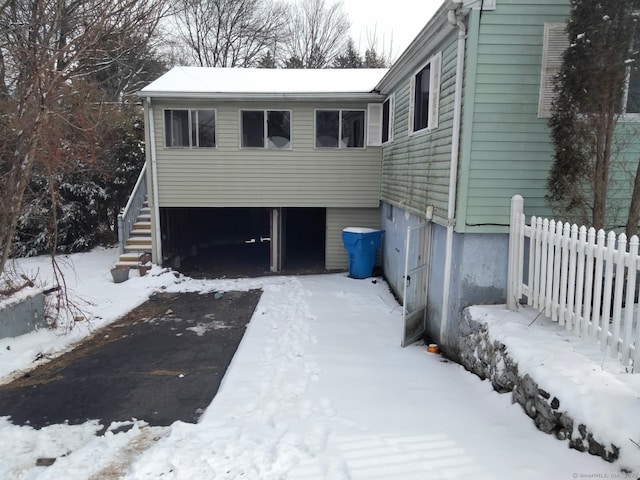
left=538, top=23, right=569, bottom=118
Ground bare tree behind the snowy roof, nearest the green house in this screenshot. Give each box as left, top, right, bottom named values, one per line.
left=284, top=0, right=351, bottom=68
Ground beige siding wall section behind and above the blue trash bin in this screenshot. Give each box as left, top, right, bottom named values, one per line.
left=325, top=208, right=380, bottom=270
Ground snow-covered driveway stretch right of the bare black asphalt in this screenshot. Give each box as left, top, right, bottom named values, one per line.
left=121, top=275, right=616, bottom=480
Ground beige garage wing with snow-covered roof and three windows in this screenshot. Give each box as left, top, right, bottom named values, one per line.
left=121, top=67, right=385, bottom=272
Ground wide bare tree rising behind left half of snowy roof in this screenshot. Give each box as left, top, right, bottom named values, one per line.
left=174, top=0, right=286, bottom=67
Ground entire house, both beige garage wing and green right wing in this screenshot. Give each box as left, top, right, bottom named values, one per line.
left=127, top=0, right=640, bottom=355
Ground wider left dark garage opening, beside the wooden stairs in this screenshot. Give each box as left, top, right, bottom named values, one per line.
left=160, top=208, right=270, bottom=278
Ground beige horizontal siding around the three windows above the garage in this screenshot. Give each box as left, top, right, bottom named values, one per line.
left=153, top=100, right=382, bottom=208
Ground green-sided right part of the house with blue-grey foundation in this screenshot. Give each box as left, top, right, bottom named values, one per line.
left=377, top=0, right=569, bottom=356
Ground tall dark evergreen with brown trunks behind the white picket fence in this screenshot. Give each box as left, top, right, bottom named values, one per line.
left=547, top=0, right=640, bottom=232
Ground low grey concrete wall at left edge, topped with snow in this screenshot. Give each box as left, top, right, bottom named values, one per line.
left=0, top=291, right=47, bottom=338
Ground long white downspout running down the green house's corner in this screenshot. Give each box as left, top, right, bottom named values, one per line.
left=440, top=10, right=467, bottom=345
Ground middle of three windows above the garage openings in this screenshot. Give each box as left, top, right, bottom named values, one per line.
left=240, top=110, right=291, bottom=150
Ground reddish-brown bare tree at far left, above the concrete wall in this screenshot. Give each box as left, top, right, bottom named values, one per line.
left=0, top=0, right=165, bottom=273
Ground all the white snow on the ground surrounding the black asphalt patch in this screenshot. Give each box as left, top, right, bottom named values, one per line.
left=0, top=249, right=640, bottom=480
